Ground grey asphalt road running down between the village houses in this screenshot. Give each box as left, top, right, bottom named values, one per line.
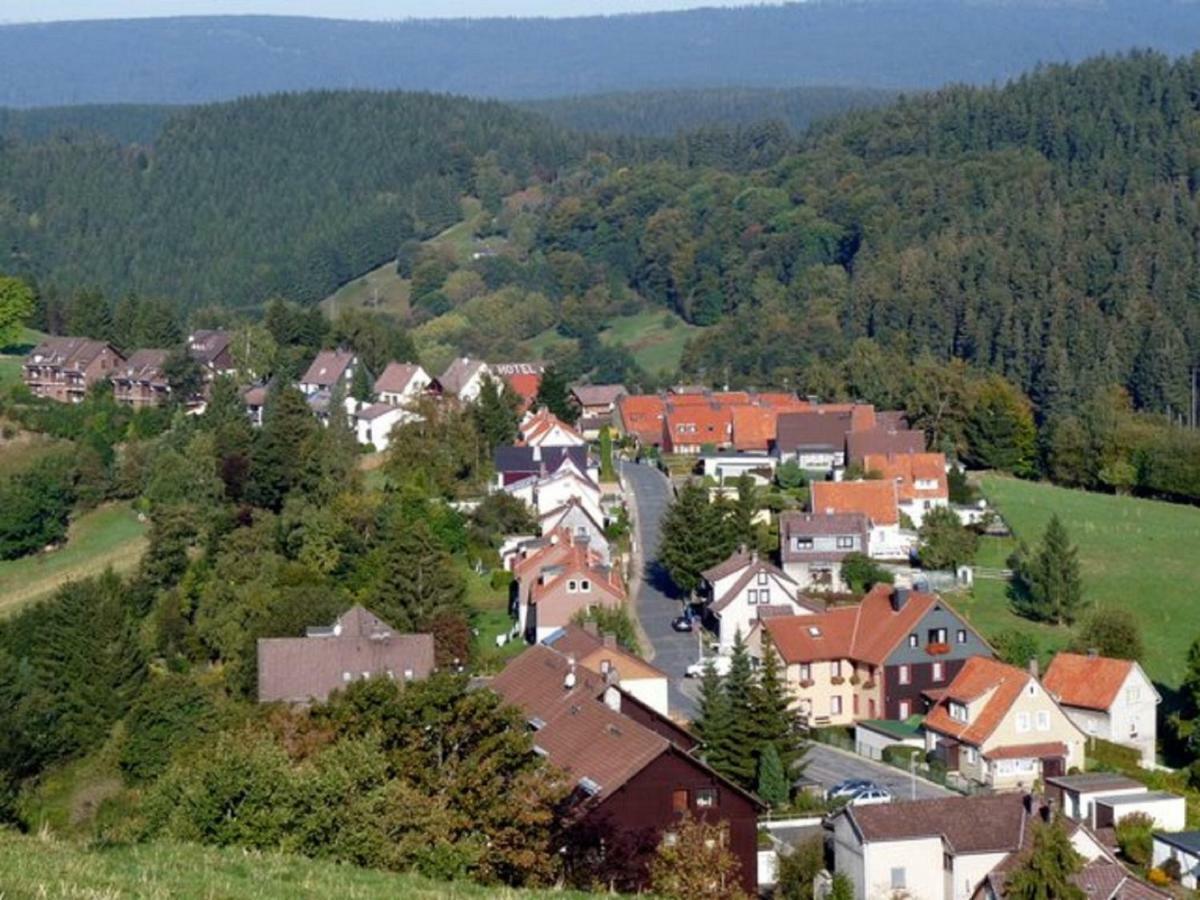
left=620, top=461, right=700, bottom=719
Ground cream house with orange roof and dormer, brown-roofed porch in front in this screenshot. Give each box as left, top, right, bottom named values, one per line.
left=924, top=656, right=1087, bottom=790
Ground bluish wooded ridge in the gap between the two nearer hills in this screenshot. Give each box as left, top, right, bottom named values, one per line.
left=522, top=86, right=896, bottom=137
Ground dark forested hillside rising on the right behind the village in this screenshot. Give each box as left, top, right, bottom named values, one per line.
left=525, top=54, right=1200, bottom=427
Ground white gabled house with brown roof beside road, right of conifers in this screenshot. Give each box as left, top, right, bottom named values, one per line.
left=701, top=550, right=824, bottom=655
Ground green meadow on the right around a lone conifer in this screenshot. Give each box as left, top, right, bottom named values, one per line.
left=956, top=475, right=1200, bottom=688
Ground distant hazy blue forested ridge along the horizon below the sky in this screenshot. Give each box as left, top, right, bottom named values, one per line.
left=0, top=0, right=1200, bottom=107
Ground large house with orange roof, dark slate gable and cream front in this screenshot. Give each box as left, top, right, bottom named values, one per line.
left=748, top=584, right=991, bottom=726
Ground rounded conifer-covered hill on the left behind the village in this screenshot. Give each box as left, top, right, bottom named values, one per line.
left=0, top=92, right=604, bottom=306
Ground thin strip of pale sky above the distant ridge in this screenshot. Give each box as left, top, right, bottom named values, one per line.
left=0, top=0, right=768, bottom=23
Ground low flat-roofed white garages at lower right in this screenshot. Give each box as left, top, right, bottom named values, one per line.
left=1045, top=772, right=1188, bottom=832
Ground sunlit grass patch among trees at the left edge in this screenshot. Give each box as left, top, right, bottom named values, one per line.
left=0, top=503, right=146, bottom=616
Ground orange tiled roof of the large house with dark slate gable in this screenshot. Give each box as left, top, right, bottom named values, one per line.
left=766, top=584, right=953, bottom=666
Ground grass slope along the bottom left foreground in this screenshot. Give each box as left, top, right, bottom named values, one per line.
left=0, top=830, right=587, bottom=900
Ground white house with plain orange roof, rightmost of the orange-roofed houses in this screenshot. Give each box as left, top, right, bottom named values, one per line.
left=1042, top=653, right=1163, bottom=768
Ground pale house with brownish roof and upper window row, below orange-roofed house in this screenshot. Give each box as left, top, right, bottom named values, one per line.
left=779, top=510, right=871, bottom=592
